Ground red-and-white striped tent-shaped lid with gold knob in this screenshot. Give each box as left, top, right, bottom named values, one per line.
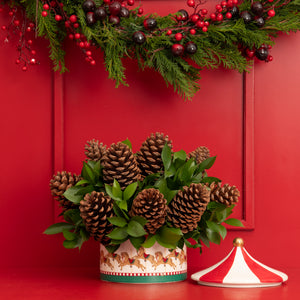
left=191, top=238, right=288, bottom=288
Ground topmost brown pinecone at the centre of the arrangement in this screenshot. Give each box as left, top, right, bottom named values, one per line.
left=137, top=132, right=172, bottom=176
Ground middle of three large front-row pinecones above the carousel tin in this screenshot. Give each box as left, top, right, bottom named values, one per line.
left=129, top=188, right=167, bottom=234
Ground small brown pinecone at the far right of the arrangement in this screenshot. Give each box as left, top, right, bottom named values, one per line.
left=209, top=182, right=240, bottom=206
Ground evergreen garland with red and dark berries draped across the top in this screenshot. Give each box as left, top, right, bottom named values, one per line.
left=2, top=0, right=300, bottom=100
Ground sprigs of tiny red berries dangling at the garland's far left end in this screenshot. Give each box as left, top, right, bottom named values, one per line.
left=0, top=7, right=39, bottom=71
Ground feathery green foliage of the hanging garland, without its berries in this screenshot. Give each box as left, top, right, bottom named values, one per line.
left=11, top=0, right=300, bottom=100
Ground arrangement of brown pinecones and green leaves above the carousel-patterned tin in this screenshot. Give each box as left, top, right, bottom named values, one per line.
left=50, top=133, right=244, bottom=250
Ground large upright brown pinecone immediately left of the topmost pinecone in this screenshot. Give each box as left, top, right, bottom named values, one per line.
left=102, top=142, right=140, bottom=189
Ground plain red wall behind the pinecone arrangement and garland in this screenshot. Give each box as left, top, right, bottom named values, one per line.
left=0, top=1, right=300, bottom=270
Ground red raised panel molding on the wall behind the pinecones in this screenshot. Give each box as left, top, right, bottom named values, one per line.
left=53, top=71, right=255, bottom=230
